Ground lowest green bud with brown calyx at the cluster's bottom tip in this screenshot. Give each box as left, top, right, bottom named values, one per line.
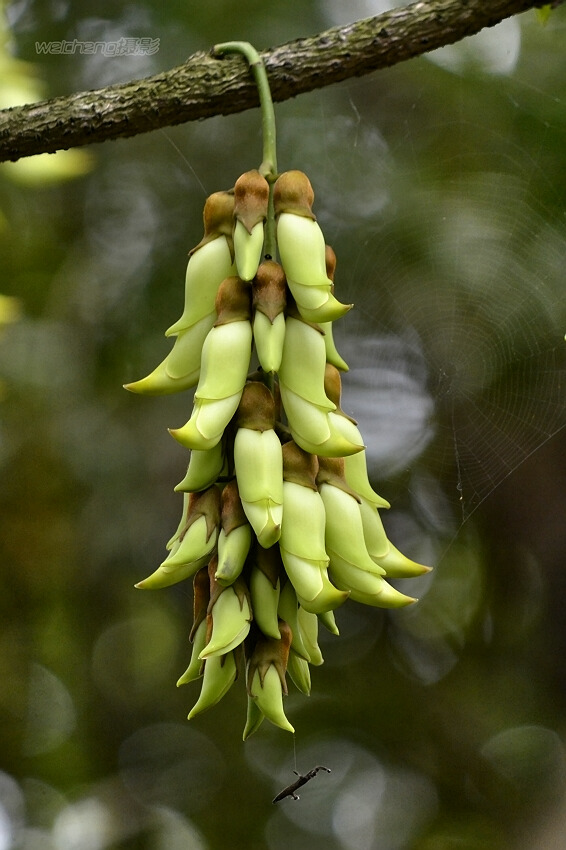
left=247, top=621, right=295, bottom=732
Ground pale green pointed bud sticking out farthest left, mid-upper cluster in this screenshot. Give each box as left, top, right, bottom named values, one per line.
left=124, top=310, right=216, bottom=395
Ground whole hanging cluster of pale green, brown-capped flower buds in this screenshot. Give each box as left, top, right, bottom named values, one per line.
left=126, top=171, right=428, bottom=739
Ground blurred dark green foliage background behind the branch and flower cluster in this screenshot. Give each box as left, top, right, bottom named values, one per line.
left=0, top=0, right=566, bottom=850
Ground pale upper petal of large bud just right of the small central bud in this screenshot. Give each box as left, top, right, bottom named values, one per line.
left=279, top=316, right=336, bottom=410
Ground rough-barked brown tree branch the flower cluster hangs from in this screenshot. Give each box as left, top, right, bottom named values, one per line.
left=0, top=0, right=562, bottom=162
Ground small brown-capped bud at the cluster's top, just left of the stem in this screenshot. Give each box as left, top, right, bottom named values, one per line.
left=234, top=170, right=269, bottom=280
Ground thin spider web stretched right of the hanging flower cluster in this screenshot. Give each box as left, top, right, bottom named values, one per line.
left=292, top=43, right=566, bottom=522
